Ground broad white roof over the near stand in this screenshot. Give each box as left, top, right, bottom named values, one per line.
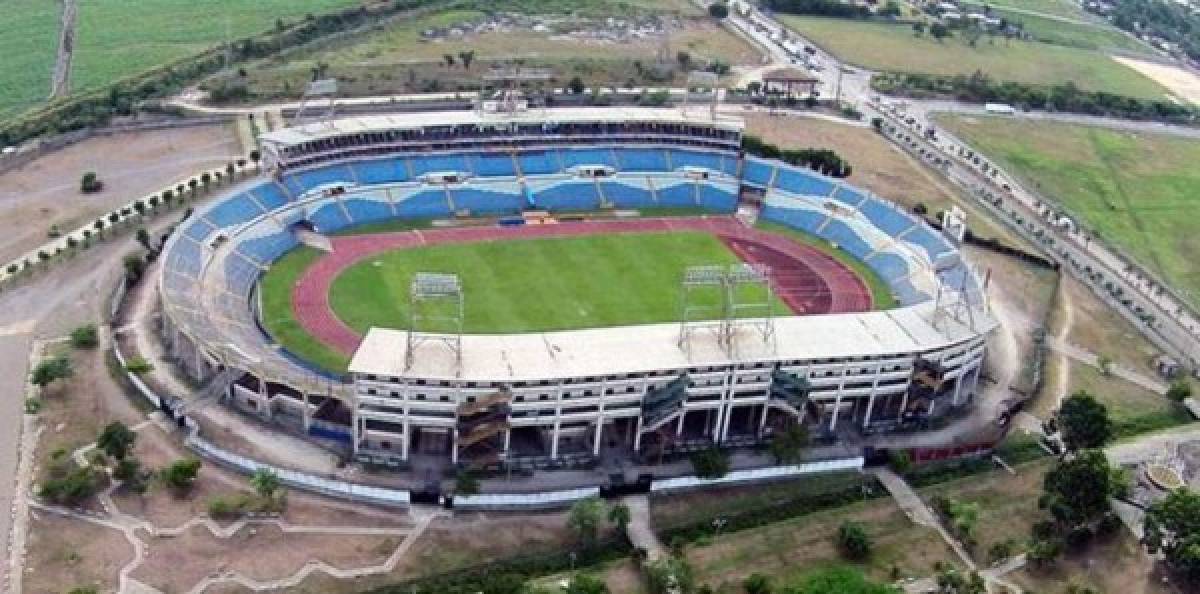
left=349, top=302, right=995, bottom=382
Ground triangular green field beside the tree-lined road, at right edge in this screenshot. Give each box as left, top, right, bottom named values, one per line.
left=938, top=116, right=1200, bottom=312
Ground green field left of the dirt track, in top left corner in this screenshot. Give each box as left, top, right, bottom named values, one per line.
left=0, top=0, right=61, bottom=119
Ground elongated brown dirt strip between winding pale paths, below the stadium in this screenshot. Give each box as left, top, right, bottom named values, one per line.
left=133, top=526, right=400, bottom=592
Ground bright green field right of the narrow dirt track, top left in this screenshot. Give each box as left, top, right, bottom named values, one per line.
left=69, top=0, right=361, bottom=90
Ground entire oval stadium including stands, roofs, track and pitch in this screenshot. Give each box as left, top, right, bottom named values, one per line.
left=158, top=108, right=996, bottom=469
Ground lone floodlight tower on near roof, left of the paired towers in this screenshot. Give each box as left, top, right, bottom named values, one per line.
left=404, top=272, right=464, bottom=374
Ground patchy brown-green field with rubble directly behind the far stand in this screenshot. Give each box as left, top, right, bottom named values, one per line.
left=228, top=0, right=758, bottom=97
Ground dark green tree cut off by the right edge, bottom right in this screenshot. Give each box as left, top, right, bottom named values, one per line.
left=1142, top=488, right=1200, bottom=582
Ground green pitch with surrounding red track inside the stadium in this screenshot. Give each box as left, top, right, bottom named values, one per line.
left=263, top=217, right=890, bottom=368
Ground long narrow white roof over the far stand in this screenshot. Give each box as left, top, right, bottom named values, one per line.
left=260, top=107, right=744, bottom=146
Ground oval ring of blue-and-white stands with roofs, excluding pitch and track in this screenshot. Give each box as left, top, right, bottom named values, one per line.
left=158, top=109, right=995, bottom=464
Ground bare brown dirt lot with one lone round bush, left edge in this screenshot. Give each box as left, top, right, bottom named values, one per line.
left=0, top=125, right=240, bottom=262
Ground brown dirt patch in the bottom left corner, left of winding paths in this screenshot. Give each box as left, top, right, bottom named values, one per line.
left=22, top=510, right=133, bottom=594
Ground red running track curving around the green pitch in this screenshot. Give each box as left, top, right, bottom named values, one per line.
left=292, top=217, right=871, bottom=355
